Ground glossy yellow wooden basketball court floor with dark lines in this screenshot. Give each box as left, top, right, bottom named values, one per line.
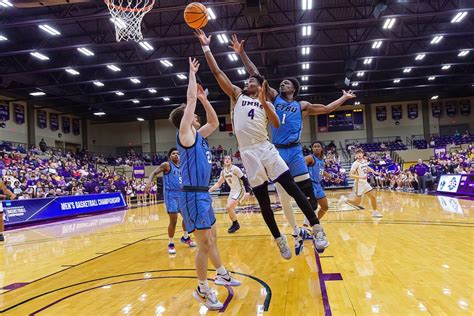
left=0, top=191, right=474, bottom=315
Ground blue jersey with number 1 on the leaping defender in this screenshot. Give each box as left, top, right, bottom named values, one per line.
left=271, top=95, right=303, bottom=145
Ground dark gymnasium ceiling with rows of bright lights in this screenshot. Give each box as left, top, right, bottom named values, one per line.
left=0, top=0, right=474, bottom=122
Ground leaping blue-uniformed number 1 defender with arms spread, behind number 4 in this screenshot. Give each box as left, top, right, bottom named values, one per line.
left=230, top=35, right=355, bottom=255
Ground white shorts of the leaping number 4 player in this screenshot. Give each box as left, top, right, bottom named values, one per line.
left=239, top=141, right=288, bottom=188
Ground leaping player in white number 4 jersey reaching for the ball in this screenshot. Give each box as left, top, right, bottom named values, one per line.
left=196, top=30, right=329, bottom=259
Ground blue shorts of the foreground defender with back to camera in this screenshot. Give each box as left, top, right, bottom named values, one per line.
left=180, top=192, right=216, bottom=233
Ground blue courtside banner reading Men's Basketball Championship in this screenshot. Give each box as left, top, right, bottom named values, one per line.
left=2, top=192, right=126, bottom=226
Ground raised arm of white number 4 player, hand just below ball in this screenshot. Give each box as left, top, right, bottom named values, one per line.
left=194, top=30, right=242, bottom=100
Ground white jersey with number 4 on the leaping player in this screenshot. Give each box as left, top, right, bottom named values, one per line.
left=232, top=94, right=273, bottom=148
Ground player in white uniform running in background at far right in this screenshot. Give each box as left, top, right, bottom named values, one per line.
left=339, top=149, right=382, bottom=217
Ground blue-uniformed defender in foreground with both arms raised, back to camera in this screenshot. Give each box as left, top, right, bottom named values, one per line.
left=170, top=58, right=240, bottom=310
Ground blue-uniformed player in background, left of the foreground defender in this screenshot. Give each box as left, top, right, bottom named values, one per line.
left=146, top=147, right=196, bottom=255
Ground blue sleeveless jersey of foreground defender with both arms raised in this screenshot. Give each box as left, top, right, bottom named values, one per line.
left=176, top=132, right=212, bottom=187
